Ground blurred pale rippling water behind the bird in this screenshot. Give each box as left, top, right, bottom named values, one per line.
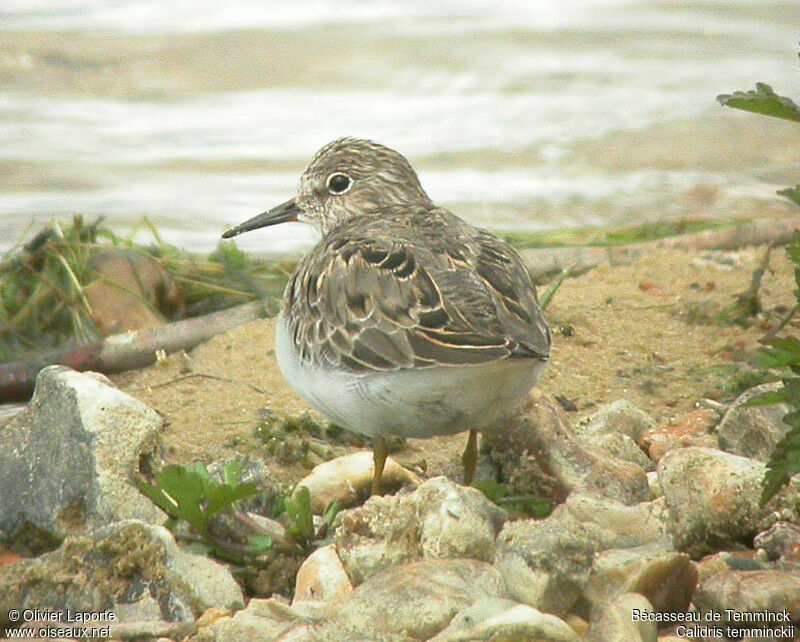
left=0, top=0, right=800, bottom=252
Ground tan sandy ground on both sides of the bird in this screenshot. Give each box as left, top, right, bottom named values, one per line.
left=113, top=247, right=800, bottom=483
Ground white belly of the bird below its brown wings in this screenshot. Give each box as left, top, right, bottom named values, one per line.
left=275, top=315, right=546, bottom=437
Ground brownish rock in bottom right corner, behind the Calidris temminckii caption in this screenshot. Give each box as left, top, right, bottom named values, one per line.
left=694, top=570, right=800, bottom=628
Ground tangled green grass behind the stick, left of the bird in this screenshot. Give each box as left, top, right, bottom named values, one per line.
left=0, top=215, right=293, bottom=362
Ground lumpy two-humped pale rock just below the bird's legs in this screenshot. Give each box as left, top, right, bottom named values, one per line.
left=334, top=477, right=505, bottom=585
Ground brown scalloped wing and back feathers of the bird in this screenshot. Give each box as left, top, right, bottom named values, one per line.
left=284, top=210, right=550, bottom=373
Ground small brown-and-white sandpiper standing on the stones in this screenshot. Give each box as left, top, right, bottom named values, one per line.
left=223, top=138, right=550, bottom=494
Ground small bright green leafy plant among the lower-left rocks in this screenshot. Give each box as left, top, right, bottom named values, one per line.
left=139, top=460, right=272, bottom=561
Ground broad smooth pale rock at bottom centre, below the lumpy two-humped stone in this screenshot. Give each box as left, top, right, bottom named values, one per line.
left=317, top=559, right=506, bottom=641
